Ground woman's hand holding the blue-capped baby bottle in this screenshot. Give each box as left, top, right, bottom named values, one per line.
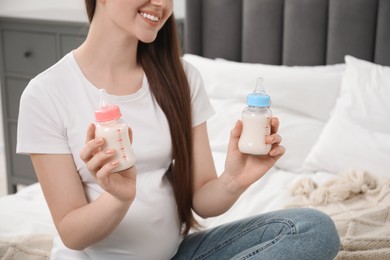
left=224, top=117, right=285, bottom=191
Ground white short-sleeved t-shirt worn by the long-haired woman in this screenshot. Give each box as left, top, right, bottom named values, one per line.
left=17, top=52, right=214, bottom=260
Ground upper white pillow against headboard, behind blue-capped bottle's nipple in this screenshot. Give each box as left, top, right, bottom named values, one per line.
left=184, top=54, right=345, bottom=121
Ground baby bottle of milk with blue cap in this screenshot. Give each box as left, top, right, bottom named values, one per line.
left=238, top=78, right=272, bottom=155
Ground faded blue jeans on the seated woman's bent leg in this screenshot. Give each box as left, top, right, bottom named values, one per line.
left=172, top=208, right=340, bottom=260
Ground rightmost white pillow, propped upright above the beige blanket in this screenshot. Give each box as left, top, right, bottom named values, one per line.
left=304, top=56, right=390, bottom=176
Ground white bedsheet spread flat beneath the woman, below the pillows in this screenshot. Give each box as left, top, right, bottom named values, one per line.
left=0, top=158, right=334, bottom=238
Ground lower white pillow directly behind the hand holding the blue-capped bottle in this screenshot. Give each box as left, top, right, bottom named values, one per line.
left=207, top=101, right=325, bottom=172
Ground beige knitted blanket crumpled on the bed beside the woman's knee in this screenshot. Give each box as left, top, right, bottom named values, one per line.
left=286, top=171, right=390, bottom=260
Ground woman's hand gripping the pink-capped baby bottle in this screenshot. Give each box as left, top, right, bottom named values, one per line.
left=80, top=124, right=137, bottom=202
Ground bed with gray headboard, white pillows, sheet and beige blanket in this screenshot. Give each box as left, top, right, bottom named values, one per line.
left=0, top=0, right=390, bottom=259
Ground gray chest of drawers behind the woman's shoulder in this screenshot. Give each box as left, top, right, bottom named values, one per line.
left=0, top=18, right=88, bottom=193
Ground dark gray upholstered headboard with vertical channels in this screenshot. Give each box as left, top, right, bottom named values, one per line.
left=184, top=0, right=390, bottom=65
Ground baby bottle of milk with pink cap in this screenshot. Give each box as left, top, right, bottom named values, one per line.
left=95, top=89, right=135, bottom=172
